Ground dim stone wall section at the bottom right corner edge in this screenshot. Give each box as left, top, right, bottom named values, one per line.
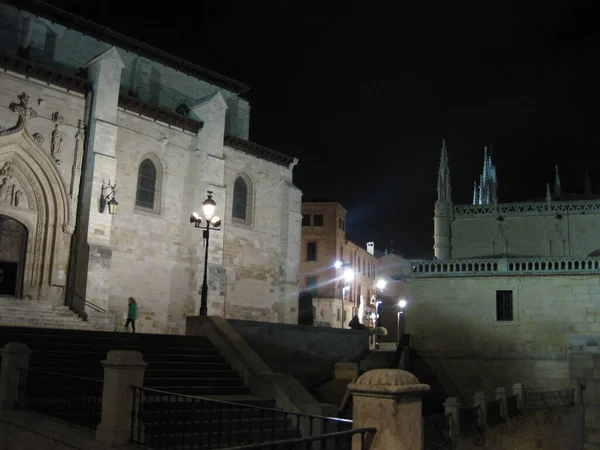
left=568, top=334, right=600, bottom=450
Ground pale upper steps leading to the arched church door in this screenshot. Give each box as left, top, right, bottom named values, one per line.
left=0, top=297, right=90, bottom=330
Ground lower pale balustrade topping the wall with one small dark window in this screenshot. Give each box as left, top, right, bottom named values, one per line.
left=410, top=257, right=600, bottom=277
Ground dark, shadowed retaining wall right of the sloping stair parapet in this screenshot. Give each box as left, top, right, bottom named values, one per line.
left=228, top=320, right=369, bottom=387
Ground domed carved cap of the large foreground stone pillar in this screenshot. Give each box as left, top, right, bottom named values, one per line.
left=348, top=369, right=429, bottom=394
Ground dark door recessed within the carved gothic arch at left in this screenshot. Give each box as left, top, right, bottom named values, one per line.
left=0, top=215, right=27, bottom=298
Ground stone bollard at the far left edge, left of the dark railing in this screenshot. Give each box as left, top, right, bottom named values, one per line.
left=0, top=342, right=31, bottom=410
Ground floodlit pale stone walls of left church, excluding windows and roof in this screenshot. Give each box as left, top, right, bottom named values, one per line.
left=0, top=14, right=301, bottom=333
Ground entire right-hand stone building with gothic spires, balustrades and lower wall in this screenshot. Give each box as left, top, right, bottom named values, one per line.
left=405, top=140, right=600, bottom=395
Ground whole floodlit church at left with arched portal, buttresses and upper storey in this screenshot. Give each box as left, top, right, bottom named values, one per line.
left=0, top=2, right=301, bottom=333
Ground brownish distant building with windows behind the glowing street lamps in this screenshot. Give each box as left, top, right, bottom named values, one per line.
left=300, top=202, right=379, bottom=328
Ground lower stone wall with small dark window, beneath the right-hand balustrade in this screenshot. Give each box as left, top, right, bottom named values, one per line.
left=405, top=275, right=600, bottom=395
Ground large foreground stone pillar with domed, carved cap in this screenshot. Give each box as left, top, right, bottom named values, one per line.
left=348, top=369, right=429, bottom=450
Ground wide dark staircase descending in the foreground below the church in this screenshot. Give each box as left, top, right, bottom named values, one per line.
left=0, top=327, right=297, bottom=444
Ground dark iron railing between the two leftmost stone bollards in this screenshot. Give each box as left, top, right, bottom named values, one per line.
left=15, top=369, right=103, bottom=430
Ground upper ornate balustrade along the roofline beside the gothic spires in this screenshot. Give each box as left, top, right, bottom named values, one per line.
left=454, top=200, right=600, bottom=218
